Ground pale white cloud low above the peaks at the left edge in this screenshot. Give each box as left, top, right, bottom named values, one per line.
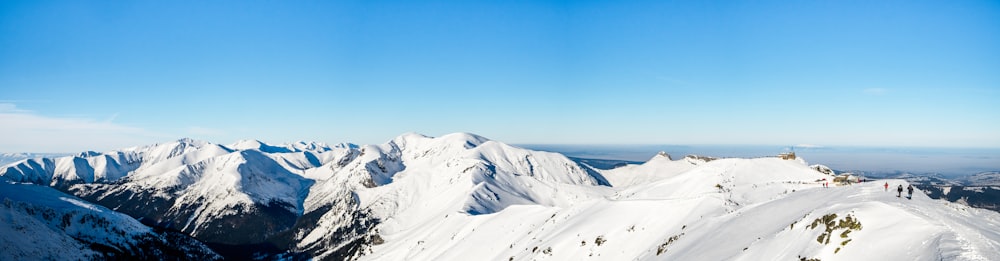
left=0, top=103, right=171, bottom=152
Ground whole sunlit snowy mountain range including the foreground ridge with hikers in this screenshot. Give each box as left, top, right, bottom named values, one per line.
left=0, top=133, right=1000, bottom=260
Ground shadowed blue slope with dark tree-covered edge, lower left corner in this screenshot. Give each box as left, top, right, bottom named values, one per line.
left=0, top=182, right=221, bottom=260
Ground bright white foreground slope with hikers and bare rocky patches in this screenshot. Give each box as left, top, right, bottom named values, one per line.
left=364, top=154, right=1000, bottom=260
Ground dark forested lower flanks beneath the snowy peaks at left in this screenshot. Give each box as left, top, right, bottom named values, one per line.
left=69, top=181, right=381, bottom=260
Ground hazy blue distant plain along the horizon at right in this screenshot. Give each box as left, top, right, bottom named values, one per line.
left=519, top=144, right=1000, bottom=177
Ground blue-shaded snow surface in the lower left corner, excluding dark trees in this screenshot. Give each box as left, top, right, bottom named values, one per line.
left=0, top=182, right=151, bottom=260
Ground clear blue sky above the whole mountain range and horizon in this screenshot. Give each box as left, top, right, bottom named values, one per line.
left=0, top=1, right=1000, bottom=152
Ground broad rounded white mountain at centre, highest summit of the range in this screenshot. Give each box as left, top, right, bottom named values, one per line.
left=297, top=133, right=609, bottom=258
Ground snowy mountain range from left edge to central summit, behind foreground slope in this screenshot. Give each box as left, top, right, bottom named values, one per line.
left=0, top=133, right=609, bottom=258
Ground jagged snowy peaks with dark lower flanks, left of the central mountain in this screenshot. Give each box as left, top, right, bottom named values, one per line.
left=0, top=139, right=353, bottom=256
